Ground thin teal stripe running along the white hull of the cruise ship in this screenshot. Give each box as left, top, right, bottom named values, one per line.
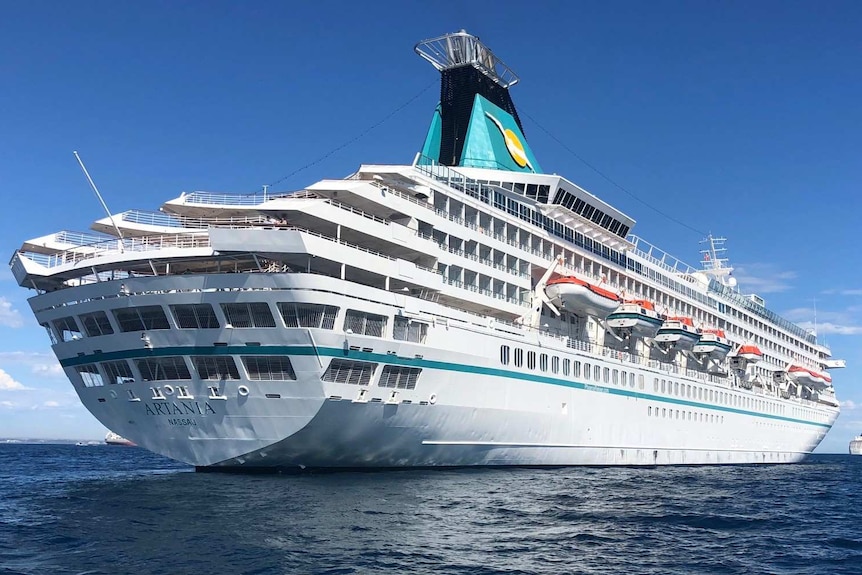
left=60, top=345, right=831, bottom=429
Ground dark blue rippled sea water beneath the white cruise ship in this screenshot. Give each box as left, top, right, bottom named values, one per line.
left=0, top=445, right=862, bottom=575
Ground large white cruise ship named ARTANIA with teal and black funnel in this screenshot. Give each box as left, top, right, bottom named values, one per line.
left=10, top=31, right=843, bottom=471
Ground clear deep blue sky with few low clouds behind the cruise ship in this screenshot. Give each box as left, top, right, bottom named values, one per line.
left=0, top=1, right=862, bottom=452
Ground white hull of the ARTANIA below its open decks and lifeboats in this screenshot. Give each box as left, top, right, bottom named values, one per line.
left=50, top=274, right=837, bottom=470
